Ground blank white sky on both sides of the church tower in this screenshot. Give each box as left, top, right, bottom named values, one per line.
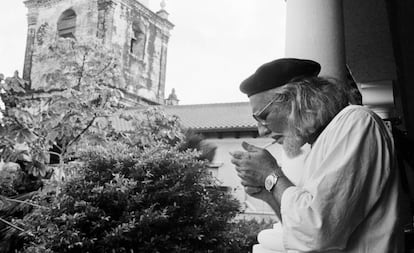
left=0, top=0, right=285, bottom=104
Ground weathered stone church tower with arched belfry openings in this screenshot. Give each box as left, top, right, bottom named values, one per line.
left=23, top=0, right=173, bottom=106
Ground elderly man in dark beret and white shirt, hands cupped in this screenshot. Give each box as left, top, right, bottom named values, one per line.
left=232, top=59, right=403, bottom=253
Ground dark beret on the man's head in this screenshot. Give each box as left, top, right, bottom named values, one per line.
left=240, top=58, right=321, bottom=97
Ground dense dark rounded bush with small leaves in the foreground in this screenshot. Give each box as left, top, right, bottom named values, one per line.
left=17, top=142, right=239, bottom=252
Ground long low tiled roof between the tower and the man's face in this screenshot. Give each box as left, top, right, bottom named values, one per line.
left=112, top=102, right=256, bottom=131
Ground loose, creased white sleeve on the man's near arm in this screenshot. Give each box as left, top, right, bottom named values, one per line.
left=281, top=109, right=393, bottom=251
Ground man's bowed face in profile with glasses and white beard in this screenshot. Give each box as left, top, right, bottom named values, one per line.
left=250, top=93, right=305, bottom=158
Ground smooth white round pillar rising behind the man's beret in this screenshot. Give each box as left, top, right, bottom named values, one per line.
left=285, top=0, right=346, bottom=81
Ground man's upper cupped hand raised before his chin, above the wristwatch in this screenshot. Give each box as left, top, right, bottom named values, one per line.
left=231, top=142, right=282, bottom=191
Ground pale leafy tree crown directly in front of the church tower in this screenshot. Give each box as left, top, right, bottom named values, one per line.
left=32, top=38, right=121, bottom=162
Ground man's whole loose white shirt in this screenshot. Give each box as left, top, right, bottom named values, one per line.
left=281, top=105, right=403, bottom=253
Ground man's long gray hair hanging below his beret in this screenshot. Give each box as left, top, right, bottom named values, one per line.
left=274, top=77, right=352, bottom=138
